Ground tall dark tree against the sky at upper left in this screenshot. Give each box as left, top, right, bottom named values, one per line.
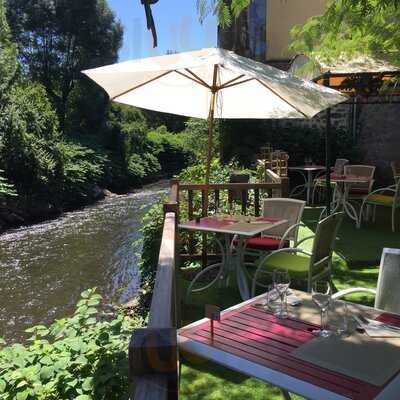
left=7, top=0, right=122, bottom=132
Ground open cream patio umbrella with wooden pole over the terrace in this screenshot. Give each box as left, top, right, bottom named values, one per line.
left=83, top=48, right=346, bottom=198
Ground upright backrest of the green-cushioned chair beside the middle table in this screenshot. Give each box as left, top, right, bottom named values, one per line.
left=312, top=212, right=344, bottom=265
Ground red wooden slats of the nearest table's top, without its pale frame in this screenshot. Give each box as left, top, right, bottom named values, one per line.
left=179, top=298, right=400, bottom=400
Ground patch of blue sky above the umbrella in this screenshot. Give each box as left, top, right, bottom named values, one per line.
left=108, top=0, right=217, bottom=61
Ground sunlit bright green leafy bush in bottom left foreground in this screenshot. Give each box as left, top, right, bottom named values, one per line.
left=0, top=289, right=141, bottom=400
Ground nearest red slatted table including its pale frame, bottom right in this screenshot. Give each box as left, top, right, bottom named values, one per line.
left=178, top=296, right=400, bottom=400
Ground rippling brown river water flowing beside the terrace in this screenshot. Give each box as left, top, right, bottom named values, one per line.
left=0, top=183, right=167, bottom=340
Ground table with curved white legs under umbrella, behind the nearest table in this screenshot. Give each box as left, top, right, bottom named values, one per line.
left=179, top=216, right=287, bottom=300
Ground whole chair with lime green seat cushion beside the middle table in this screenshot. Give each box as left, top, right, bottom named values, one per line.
left=252, top=212, right=344, bottom=296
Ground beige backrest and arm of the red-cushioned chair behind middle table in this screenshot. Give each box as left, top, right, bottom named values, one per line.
left=263, top=198, right=306, bottom=246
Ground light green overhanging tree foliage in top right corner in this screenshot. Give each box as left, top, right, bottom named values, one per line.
left=291, top=0, right=400, bottom=65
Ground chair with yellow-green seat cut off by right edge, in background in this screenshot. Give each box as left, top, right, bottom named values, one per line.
left=357, top=176, right=400, bottom=232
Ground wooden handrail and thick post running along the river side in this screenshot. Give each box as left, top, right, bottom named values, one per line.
left=129, top=182, right=179, bottom=400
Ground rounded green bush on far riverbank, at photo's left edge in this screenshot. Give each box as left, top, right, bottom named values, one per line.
left=0, top=84, right=62, bottom=197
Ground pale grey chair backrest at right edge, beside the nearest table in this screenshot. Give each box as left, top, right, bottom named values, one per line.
left=375, top=248, right=400, bottom=314
